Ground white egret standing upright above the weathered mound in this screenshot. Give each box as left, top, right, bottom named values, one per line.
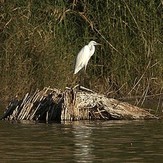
left=74, top=41, right=101, bottom=74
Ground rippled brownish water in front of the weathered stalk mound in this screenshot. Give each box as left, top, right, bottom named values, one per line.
left=0, top=120, right=163, bottom=163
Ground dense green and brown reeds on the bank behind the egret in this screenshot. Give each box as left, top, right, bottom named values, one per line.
left=0, top=0, right=163, bottom=100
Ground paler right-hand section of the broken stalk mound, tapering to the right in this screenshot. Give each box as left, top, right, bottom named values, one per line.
left=65, top=86, right=157, bottom=120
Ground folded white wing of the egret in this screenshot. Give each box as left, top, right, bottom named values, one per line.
left=74, top=45, right=89, bottom=74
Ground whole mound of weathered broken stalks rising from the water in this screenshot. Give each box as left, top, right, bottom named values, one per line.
left=1, top=86, right=158, bottom=122
